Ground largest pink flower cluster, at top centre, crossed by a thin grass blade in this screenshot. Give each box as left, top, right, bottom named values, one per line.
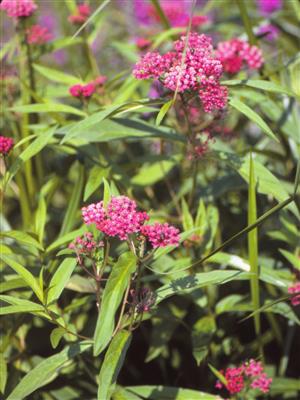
left=133, top=33, right=227, bottom=112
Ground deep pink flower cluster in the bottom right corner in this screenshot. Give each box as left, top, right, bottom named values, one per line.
left=216, top=359, right=272, bottom=395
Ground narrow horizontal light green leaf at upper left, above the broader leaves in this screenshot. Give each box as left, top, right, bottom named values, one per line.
left=9, top=103, right=86, bottom=117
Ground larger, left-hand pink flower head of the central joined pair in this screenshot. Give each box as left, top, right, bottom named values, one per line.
left=82, top=196, right=149, bottom=240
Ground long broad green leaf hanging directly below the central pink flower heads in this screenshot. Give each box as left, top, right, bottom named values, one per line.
left=94, top=252, right=136, bottom=356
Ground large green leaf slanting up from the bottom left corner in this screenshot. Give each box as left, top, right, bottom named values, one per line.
left=7, top=342, right=91, bottom=400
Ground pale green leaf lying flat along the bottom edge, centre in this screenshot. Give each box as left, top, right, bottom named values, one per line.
left=126, top=386, right=221, bottom=400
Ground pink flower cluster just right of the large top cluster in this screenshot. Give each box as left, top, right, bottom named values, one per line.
left=216, top=39, right=264, bottom=74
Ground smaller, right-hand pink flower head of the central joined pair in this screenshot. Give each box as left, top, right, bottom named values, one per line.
left=141, top=222, right=180, bottom=248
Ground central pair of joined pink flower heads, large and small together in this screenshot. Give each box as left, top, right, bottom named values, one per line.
left=82, top=196, right=179, bottom=248
